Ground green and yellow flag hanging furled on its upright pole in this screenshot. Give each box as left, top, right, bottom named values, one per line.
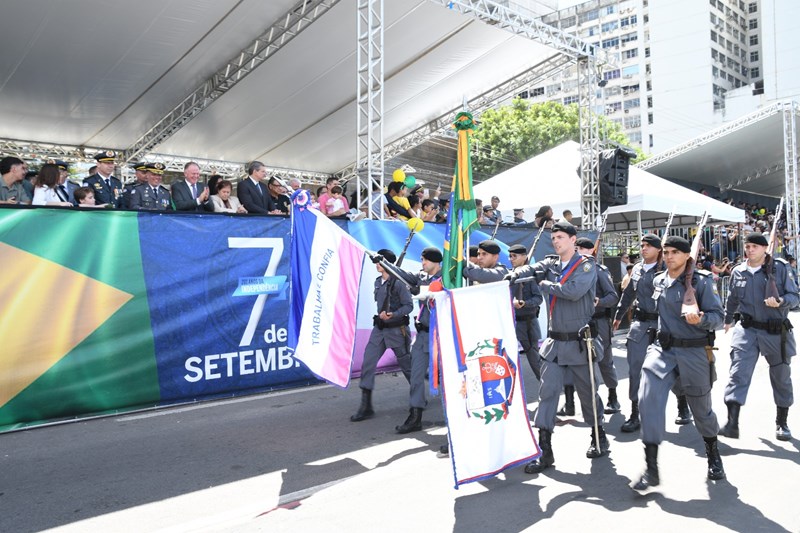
left=442, top=112, right=478, bottom=289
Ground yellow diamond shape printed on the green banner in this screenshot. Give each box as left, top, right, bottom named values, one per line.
left=0, top=243, right=133, bottom=407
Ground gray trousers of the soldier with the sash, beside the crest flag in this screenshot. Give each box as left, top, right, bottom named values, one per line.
left=533, top=339, right=603, bottom=431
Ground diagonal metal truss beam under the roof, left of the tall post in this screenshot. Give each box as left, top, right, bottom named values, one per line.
left=123, top=0, right=339, bottom=162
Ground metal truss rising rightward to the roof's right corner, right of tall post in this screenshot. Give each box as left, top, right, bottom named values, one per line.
left=337, top=54, right=573, bottom=180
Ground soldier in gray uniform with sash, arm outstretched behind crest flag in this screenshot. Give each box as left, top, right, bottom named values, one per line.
left=508, top=221, right=608, bottom=474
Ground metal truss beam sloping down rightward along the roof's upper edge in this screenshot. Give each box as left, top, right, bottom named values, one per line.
left=430, top=0, right=608, bottom=62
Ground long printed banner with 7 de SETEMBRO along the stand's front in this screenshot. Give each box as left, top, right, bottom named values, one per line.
left=0, top=208, right=591, bottom=431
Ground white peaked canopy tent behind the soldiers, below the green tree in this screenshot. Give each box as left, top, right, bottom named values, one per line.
left=474, top=141, right=745, bottom=231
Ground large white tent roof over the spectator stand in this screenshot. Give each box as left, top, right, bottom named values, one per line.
left=0, top=0, right=556, bottom=173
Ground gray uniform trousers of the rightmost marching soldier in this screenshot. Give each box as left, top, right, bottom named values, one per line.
left=725, top=324, right=794, bottom=407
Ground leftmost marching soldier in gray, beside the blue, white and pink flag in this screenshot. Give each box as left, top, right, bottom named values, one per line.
left=350, top=249, right=414, bottom=422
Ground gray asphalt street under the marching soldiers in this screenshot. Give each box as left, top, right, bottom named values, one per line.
left=0, top=313, right=800, bottom=533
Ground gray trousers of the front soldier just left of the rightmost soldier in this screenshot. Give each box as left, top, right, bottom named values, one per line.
left=639, top=344, right=719, bottom=444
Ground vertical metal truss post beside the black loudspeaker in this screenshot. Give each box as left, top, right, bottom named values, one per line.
left=578, top=57, right=600, bottom=229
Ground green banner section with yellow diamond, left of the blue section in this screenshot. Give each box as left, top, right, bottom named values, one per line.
left=0, top=209, right=160, bottom=430
